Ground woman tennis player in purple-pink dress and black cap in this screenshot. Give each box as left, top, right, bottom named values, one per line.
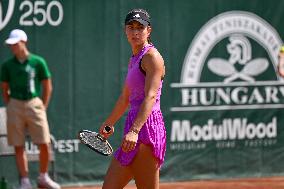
left=100, top=9, right=166, bottom=189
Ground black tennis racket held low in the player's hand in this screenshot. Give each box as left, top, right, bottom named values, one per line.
left=78, top=126, right=113, bottom=156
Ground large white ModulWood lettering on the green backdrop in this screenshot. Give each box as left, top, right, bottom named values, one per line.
left=171, top=117, right=277, bottom=142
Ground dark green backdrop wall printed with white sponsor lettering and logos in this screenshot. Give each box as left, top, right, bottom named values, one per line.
left=0, top=0, right=284, bottom=187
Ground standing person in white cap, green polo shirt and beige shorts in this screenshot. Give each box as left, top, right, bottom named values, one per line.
left=1, top=29, right=60, bottom=189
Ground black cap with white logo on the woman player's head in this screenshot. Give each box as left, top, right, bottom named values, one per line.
left=125, top=9, right=150, bottom=26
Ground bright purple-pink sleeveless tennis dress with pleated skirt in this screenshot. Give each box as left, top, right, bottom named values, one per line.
left=114, top=44, right=166, bottom=167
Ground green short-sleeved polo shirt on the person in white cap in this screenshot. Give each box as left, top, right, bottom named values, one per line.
left=1, top=54, right=51, bottom=100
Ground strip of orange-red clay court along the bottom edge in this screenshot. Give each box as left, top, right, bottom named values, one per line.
left=64, top=177, right=284, bottom=189
